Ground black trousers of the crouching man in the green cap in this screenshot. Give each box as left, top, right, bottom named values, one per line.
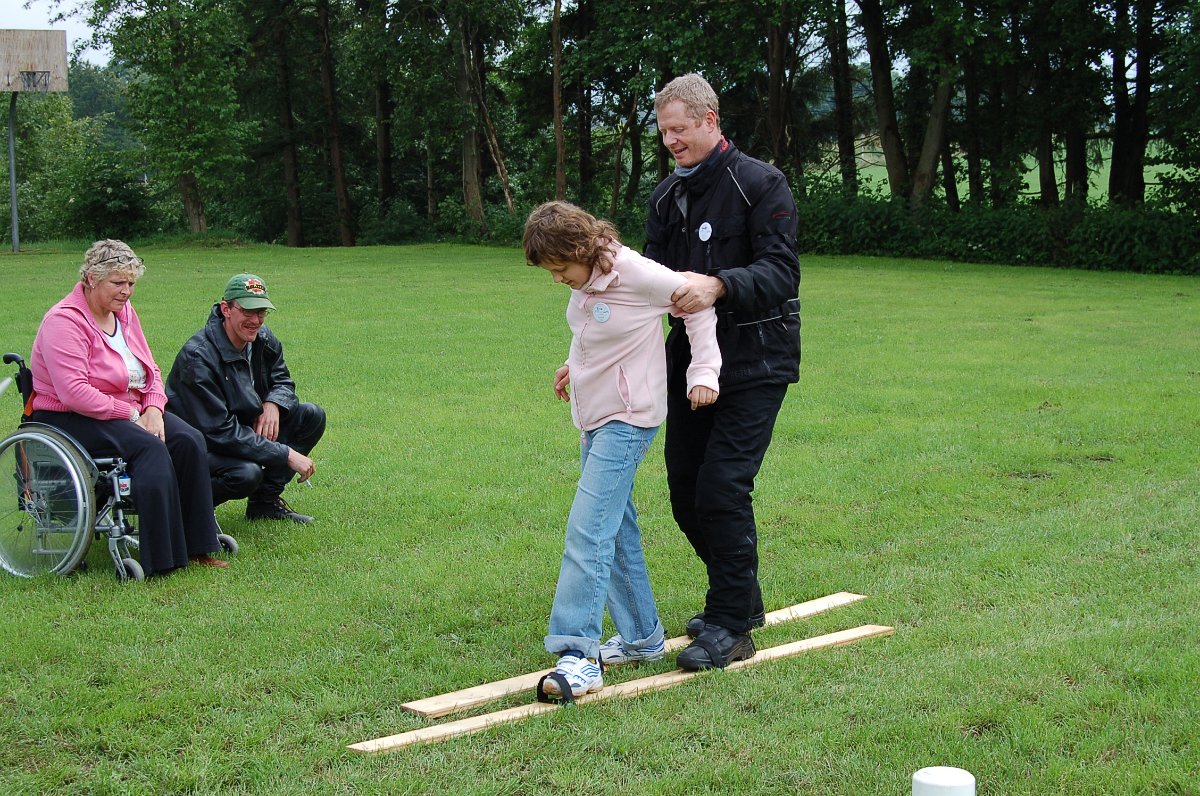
left=209, top=403, right=325, bottom=505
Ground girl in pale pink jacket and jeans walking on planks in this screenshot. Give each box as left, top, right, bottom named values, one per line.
left=524, top=202, right=721, bottom=700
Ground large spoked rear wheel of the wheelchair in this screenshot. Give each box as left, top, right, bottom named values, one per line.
left=0, top=429, right=96, bottom=577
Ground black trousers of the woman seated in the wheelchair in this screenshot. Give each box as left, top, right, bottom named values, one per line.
left=29, top=411, right=221, bottom=575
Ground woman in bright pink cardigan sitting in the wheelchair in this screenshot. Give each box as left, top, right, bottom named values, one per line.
left=29, top=240, right=229, bottom=575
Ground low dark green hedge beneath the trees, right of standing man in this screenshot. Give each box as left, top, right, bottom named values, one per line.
left=798, top=194, right=1200, bottom=274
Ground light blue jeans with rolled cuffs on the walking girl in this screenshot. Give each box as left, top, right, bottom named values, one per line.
left=546, top=420, right=665, bottom=658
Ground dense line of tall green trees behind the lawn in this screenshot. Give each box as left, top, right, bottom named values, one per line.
left=2, top=0, right=1200, bottom=267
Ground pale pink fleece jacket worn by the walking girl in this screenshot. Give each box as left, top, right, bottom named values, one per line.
left=566, top=246, right=721, bottom=431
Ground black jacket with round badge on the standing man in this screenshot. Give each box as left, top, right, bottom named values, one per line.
left=644, top=143, right=800, bottom=391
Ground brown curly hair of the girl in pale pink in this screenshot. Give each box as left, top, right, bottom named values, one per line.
left=522, top=202, right=620, bottom=274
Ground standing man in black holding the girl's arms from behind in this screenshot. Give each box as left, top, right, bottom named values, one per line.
left=644, top=74, right=800, bottom=670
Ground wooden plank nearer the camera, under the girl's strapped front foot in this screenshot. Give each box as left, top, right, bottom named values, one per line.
left=347, top=624, right=895, bottom=754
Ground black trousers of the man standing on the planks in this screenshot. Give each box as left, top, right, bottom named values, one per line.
left=664, top=379, right=787, bottom=633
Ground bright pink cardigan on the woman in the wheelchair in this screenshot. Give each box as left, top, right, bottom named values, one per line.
left=29, top=283, right=167, bottom=420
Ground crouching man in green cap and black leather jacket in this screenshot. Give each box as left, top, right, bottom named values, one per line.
left=167, top=274, right=325, bottom=522
